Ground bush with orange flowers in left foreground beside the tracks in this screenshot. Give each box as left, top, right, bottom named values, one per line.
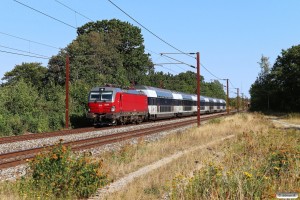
left=20, top=143, right=108, bottom=199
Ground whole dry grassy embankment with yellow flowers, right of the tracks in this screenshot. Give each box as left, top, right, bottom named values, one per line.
left=0, top=114, right=300, bottom=200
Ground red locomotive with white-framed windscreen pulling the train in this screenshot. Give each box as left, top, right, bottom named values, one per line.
left=87, top=87, right=148, bottom=125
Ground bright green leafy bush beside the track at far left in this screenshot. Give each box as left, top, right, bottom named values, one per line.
left=0, top=79, right=48, bottom=135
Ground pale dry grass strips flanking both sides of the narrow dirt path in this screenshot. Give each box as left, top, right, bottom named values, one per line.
left=98, top=114, right=272, bottom=199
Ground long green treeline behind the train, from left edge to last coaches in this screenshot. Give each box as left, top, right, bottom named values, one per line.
left=0, top=19, right=225, bottom=136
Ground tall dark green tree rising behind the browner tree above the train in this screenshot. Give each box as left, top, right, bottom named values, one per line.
left=77, top=19, right=153, bottom=82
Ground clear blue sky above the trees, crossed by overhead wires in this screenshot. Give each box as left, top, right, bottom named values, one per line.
left=0, top=0, right=300, bottom=97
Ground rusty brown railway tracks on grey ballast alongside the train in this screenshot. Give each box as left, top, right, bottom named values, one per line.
left=0, top=111, right=224, bottom=169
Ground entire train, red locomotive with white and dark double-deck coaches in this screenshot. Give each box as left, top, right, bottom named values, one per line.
left=87, top=85, right=226, bottom=126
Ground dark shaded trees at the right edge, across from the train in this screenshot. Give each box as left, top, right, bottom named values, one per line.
left=250, top=45, right=300, bottom=112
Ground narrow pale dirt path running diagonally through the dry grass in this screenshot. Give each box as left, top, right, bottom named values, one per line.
left=90, top=135, right=234, bottom=200
